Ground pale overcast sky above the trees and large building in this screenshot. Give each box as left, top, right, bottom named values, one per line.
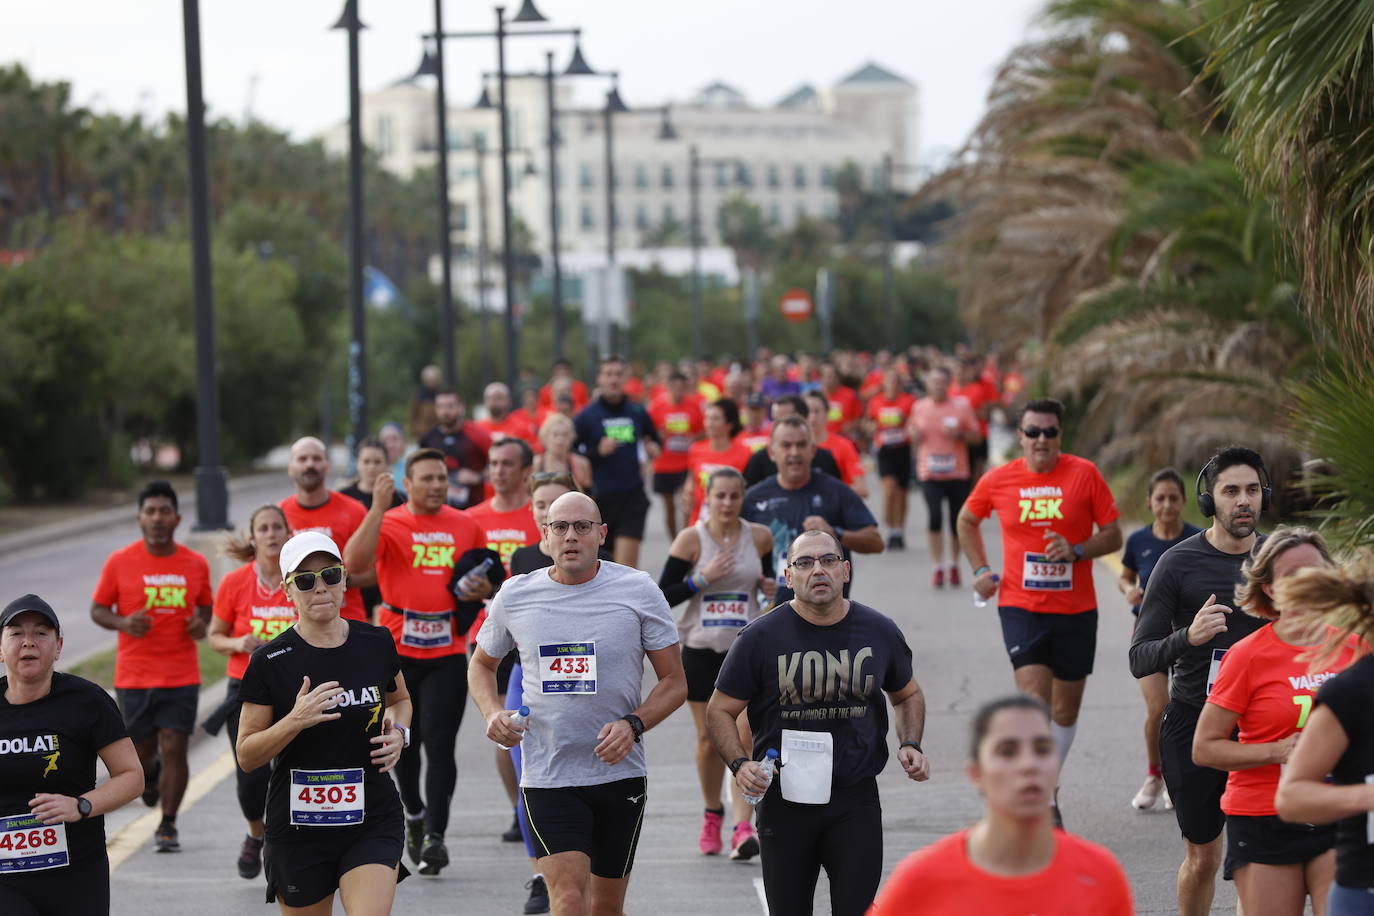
left=8, top=0, right=1044, bottom=162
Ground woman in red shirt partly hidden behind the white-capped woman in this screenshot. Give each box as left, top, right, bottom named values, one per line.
left=205, top=505, right=295, bottom=879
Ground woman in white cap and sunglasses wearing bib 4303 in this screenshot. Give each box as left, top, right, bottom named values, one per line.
left=236, top=531, right=411, bottom=916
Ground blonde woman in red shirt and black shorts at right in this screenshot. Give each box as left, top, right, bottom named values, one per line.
left=1193, top=527, right=1355, bottom=916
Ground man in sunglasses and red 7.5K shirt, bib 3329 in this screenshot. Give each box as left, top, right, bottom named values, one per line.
left=959, top=398, right=1121, bottom=827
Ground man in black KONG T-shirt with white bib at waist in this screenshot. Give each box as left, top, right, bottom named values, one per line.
left=706, top=530, right=930, bottom=916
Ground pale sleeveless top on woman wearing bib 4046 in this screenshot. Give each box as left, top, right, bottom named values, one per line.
left=677, top=519, right=764, bottom=652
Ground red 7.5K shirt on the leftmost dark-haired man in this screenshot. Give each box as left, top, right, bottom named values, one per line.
left=91, top=540, right=214, bottom=689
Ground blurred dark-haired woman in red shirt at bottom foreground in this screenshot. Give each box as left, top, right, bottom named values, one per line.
left=868, top=694, right=1134, bottom=916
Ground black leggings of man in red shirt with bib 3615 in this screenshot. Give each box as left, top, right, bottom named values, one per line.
left=396, top=655, right=467, bottom=836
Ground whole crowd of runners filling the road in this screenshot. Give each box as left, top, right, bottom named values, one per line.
left=0, top=349, right=1374, bottom=916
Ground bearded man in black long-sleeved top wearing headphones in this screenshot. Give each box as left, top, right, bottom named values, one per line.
left=1131, top=445, right=1270, bottom=916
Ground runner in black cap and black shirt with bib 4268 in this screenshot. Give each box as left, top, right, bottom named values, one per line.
left=0, top=595, right=143, bottom=916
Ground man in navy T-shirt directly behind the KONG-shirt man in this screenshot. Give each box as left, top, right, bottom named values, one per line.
left=741, top=416, right=882, bottom=603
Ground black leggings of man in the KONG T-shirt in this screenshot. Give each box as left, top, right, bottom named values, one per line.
left=758, top=779, right=882, bottom=916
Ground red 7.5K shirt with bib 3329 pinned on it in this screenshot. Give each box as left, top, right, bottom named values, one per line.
left=963, top=455, right=1120, bottom=614
